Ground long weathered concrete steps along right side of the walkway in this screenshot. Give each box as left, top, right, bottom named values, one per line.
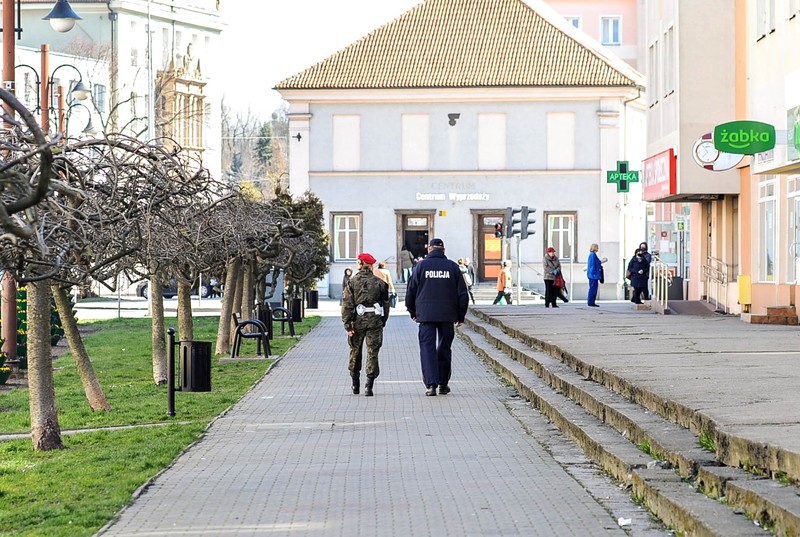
left=460, top=310, right=800, bottom=535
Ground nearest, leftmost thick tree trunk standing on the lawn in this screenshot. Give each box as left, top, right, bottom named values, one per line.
left=27, top=282, right=64, bottom=451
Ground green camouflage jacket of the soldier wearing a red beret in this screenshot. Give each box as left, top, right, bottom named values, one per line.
left=342, top=267, right=389, bottom=331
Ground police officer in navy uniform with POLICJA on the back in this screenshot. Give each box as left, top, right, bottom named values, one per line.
left=406, top=239, right=469, bottom=395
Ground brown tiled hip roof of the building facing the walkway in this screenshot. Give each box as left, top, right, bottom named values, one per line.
left=276, top=0, right=641, bottom=90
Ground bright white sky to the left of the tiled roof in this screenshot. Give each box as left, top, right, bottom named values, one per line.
left=220, top=0, right=422, bottom=119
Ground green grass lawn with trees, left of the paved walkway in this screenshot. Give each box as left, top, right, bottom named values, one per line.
left=0, top=317, right=319, bottom=537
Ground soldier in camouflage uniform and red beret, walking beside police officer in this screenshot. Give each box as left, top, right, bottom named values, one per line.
left=342, top=252, right=389, bottom=396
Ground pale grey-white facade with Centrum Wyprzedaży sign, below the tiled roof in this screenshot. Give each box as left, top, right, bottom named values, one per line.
left=282, top=88, right=645, bottom=299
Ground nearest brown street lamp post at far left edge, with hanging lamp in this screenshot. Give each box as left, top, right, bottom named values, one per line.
left=0, top=0, right=80, bottom=360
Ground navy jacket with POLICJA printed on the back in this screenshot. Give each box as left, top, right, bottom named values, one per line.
left=406, top=249, right=469, bottom=323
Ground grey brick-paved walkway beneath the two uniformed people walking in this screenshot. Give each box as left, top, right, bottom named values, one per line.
left=101, top=301, right=624, bottom=537
